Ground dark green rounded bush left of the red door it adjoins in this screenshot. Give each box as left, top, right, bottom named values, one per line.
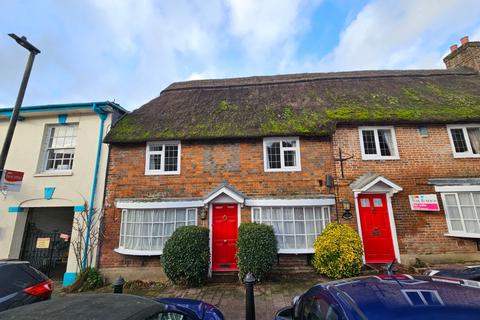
left=162, top=226, right=210, bottom=286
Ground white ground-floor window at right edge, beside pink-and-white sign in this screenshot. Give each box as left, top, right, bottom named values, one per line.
left=442, top=192, right=480, bottom=238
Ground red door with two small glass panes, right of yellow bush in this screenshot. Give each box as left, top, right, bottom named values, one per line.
left=358, top=194, right=395, bottom=263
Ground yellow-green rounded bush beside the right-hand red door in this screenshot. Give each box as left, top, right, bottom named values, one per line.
left=313, top=223, right=363, bottom=279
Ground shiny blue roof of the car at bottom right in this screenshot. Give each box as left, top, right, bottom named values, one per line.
left=313, top=274, right=480, bottom=319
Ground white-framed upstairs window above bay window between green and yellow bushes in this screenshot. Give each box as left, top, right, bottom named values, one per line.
left=263, top=137, right=301, bottom=172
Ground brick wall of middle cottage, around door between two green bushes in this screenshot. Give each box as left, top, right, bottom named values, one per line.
left=100, top=139, right=333, bottom=268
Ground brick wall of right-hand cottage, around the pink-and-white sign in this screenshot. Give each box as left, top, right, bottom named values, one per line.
left=333, top=125, right=480, bottom=254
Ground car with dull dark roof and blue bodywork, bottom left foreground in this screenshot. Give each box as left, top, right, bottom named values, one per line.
left=0, top=294, right=224, bottom=320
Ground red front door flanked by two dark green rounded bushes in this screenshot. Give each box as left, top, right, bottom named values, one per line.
left=212, top=204, right=238, bottom=271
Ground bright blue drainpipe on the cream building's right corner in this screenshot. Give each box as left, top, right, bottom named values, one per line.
left=82, top=103, right=107, bottom=271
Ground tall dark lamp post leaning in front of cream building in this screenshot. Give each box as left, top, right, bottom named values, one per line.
left=0, top=33, right=40, bottom=174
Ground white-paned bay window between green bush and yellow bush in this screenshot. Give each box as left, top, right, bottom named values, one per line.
left=252, top=206, right=330, bottom=253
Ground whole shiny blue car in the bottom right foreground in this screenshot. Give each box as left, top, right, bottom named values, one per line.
left=275, top=274, right=480, bottom=320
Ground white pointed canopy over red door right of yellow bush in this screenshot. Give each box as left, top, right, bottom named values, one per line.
left=350, top=172, right=403, bottom=194
